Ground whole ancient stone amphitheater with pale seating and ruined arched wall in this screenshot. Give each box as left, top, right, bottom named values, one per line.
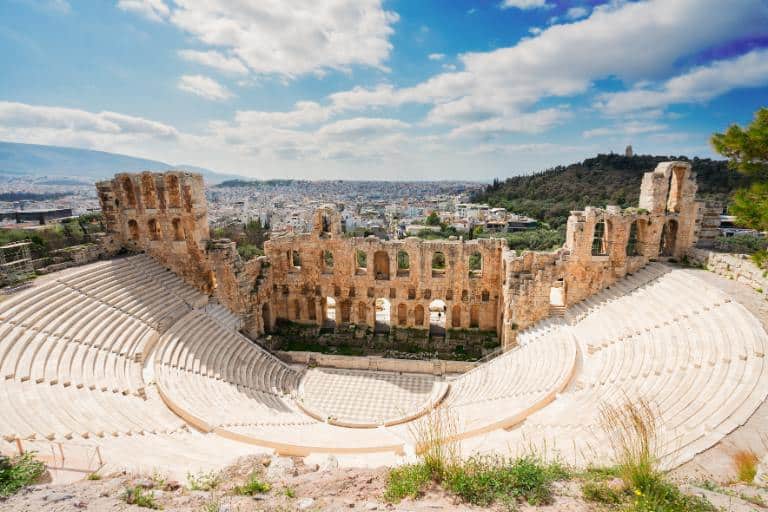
left=0, top=162, right=768, bottom=475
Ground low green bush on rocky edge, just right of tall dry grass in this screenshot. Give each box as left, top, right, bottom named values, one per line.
left=446, top=455, right=568, bottom=506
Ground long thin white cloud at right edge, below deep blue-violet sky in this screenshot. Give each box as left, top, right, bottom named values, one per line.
left=597, top=49, right=768, bottom=115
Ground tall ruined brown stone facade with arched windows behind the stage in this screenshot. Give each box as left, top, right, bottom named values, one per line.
left=97, top=162, right=702, bottom=354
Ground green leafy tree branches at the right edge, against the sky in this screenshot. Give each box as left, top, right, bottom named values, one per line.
left=711, top=107, right=768, bottom=231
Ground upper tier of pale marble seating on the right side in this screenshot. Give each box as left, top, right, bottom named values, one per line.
left=462, top=264, right=768, bottom=467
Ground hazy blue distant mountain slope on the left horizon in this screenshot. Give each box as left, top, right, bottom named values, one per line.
left=0, top=141, right=242, bottom=183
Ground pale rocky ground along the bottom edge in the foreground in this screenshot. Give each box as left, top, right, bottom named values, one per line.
left=0, top=457, right=768, bottom=512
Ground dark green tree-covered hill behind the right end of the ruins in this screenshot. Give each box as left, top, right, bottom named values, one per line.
left=472, top=154, right=749, bottom=228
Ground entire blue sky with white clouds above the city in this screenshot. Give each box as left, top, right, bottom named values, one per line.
left=0, top=0, right=768, bottom=180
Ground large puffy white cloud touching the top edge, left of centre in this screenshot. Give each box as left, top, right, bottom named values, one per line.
left=169, top=0, right=398, bottom=78
